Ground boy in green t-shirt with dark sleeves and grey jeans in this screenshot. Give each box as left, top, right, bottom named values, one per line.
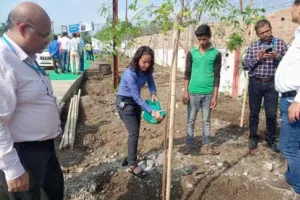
left=183, top=24, right=222, bottom=155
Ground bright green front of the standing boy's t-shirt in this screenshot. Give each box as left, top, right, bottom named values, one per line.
left=189, top=47, right=219, bottom=94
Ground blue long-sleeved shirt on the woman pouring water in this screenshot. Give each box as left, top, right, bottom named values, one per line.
left=118, top=67, right=156, bottom=113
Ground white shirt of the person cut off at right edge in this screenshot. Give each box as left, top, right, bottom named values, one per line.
left=275, top=27, right=300, bottom=103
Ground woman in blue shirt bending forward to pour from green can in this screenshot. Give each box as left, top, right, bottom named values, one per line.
left=116, top=46, right=162, bottom=178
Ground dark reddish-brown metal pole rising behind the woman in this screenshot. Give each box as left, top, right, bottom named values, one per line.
left=113, top=0, right=119, bottom=89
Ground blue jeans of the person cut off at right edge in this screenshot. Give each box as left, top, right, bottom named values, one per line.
left=279, top=97, right=300, bottom=194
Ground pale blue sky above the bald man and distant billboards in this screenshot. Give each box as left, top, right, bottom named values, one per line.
left=0, top=0, right=155, bottom=33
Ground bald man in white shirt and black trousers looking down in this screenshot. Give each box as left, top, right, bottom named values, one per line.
left=0, top=2, right=64, bottom=200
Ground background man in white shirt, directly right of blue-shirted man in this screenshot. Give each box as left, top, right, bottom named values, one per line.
left=59, top=32, right=71, bottom=72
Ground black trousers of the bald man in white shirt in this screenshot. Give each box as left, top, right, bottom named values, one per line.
left=3, top=140, right=64, bottom=200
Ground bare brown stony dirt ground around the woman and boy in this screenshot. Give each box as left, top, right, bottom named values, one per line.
left=58, top=63, right=289, bottom=200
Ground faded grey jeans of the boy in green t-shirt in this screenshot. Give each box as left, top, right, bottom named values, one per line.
left=186, top=94, right=212, bottom=145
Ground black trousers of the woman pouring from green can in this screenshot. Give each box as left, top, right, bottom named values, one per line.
left=117, top=96, right=142, bottom=166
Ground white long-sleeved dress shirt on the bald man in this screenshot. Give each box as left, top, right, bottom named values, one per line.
left=0, top=34, right=61, bottom=180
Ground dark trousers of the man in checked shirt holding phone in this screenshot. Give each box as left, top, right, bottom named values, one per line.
left=249, top=78, right=278, bottom=142
